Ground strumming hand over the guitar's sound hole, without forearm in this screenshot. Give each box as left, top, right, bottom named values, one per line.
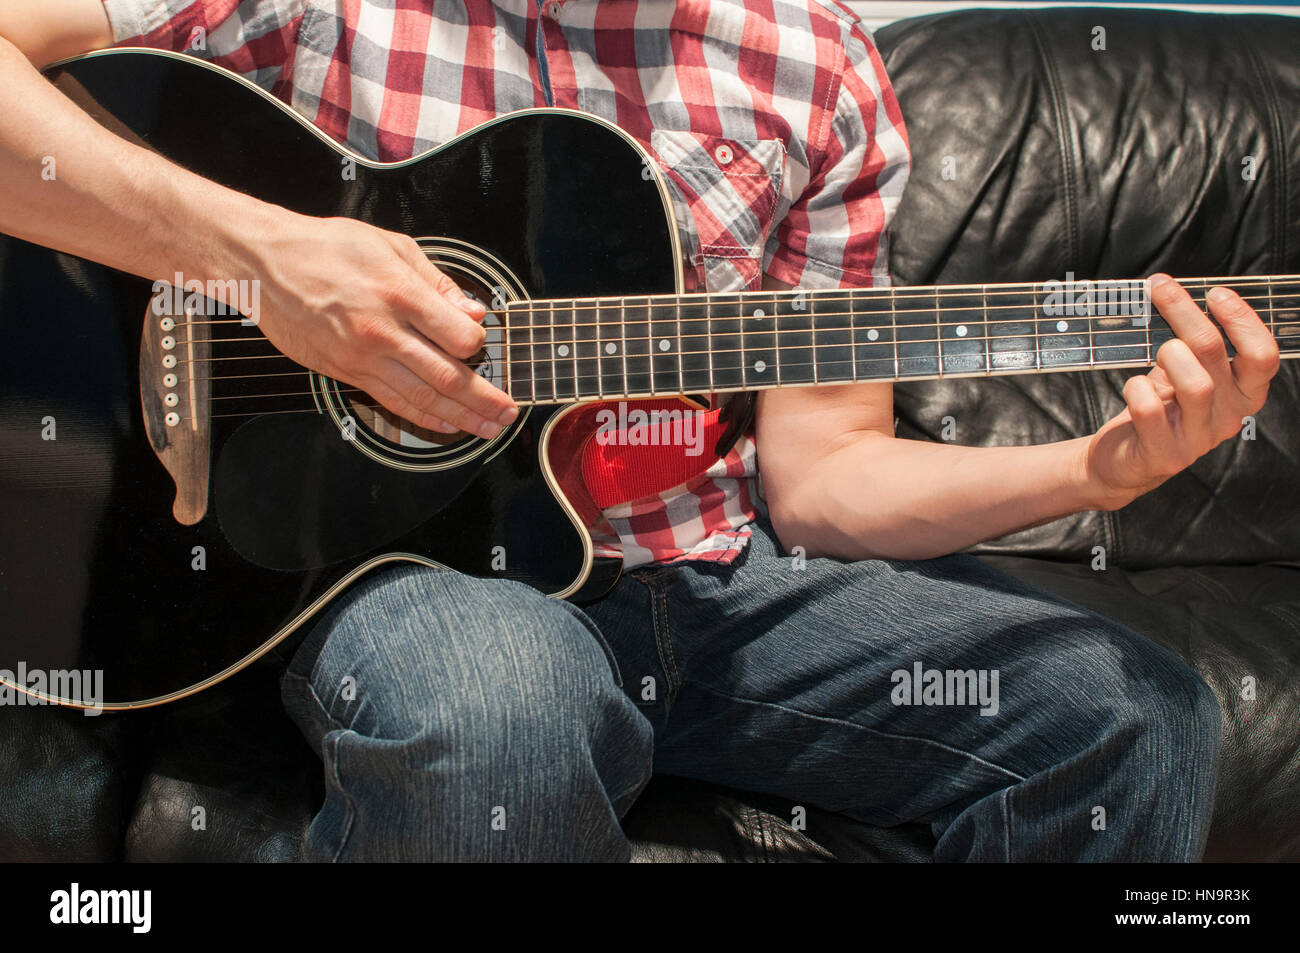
left=252, top=209, right=519, bottom=438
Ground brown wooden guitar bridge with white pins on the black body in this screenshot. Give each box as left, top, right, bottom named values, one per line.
left=140, top=289, right=212, bottom=527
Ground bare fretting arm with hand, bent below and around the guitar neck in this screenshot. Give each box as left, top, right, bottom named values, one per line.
left=757, top=271, right=1278, bottom=559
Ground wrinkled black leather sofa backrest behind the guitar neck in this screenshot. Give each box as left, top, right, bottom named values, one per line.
left=876, top=8, right=1300, bottom=568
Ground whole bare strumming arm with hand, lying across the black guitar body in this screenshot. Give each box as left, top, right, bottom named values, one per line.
left=0, top=0, right=516, bottom=437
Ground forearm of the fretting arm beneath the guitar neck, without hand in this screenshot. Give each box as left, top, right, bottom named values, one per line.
left=770, top=432, right=1110, bottom=559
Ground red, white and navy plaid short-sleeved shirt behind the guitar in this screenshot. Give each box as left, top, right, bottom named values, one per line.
left=104, top=0, right=909, bottom=567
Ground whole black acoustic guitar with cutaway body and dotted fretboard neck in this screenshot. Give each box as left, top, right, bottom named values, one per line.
left=0, top=49, right=1300, bottom=709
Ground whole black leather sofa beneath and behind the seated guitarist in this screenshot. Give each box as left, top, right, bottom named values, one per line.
left=0, top=8, right=1300, bottom=861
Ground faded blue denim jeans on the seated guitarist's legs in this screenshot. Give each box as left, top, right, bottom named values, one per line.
left=283, top=524, right=1219, bottom=861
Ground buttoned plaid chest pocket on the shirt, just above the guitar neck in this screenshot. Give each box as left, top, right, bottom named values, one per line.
left=650, top=129, right=785, bottom=291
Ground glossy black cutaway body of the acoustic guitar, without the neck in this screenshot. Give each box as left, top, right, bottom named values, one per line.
left=0, top=51, right=681, bottom=707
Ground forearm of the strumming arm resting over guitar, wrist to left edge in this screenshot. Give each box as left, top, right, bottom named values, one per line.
left=0, top=39, right=282, bottom=286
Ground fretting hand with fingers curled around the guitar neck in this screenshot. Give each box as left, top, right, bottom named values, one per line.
left=1086, top=274, right=1281, bottom=510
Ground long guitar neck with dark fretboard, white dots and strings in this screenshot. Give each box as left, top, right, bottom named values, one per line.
left=503, top=274, right=1300, bottom=404
